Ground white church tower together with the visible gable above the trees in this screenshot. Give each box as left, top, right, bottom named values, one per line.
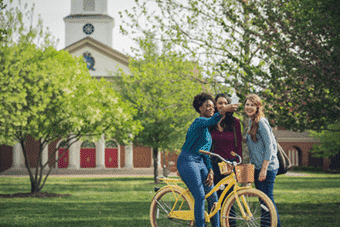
left=64, top=0, right=129, bottom=79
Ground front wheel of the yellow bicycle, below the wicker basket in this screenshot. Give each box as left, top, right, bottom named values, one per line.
left=221, top=188, right=277, bottom=227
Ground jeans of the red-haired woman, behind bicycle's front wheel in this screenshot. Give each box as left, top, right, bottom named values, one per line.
left=255, top=169, right=281, bottom=227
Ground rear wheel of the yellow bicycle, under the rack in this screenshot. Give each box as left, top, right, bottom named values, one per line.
left=150, top=187, right=195, bottom=227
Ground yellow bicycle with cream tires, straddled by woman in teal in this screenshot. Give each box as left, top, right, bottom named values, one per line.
left=150, top=151, right=277, bottom=227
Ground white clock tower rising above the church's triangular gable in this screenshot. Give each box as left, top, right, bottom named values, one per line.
left=64, top=0, right=114, bottom=47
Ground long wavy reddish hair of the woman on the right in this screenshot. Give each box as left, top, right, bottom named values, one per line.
left=244, top=94, right=265, bottom=142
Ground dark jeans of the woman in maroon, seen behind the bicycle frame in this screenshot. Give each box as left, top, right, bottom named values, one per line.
left=211, top=157, right=236, bottom=227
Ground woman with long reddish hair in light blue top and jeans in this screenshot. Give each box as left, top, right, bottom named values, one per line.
left=244, top=94, right=281, bottom=227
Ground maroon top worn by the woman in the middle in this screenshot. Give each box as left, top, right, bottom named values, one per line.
left=210, top=118, right=242, bottom=159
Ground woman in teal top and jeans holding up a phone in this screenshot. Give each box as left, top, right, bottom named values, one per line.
left=177, top=93, right=238, bottom=227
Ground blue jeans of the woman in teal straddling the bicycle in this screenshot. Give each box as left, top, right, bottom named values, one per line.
left=177, top=151, right=220, bottom=227
